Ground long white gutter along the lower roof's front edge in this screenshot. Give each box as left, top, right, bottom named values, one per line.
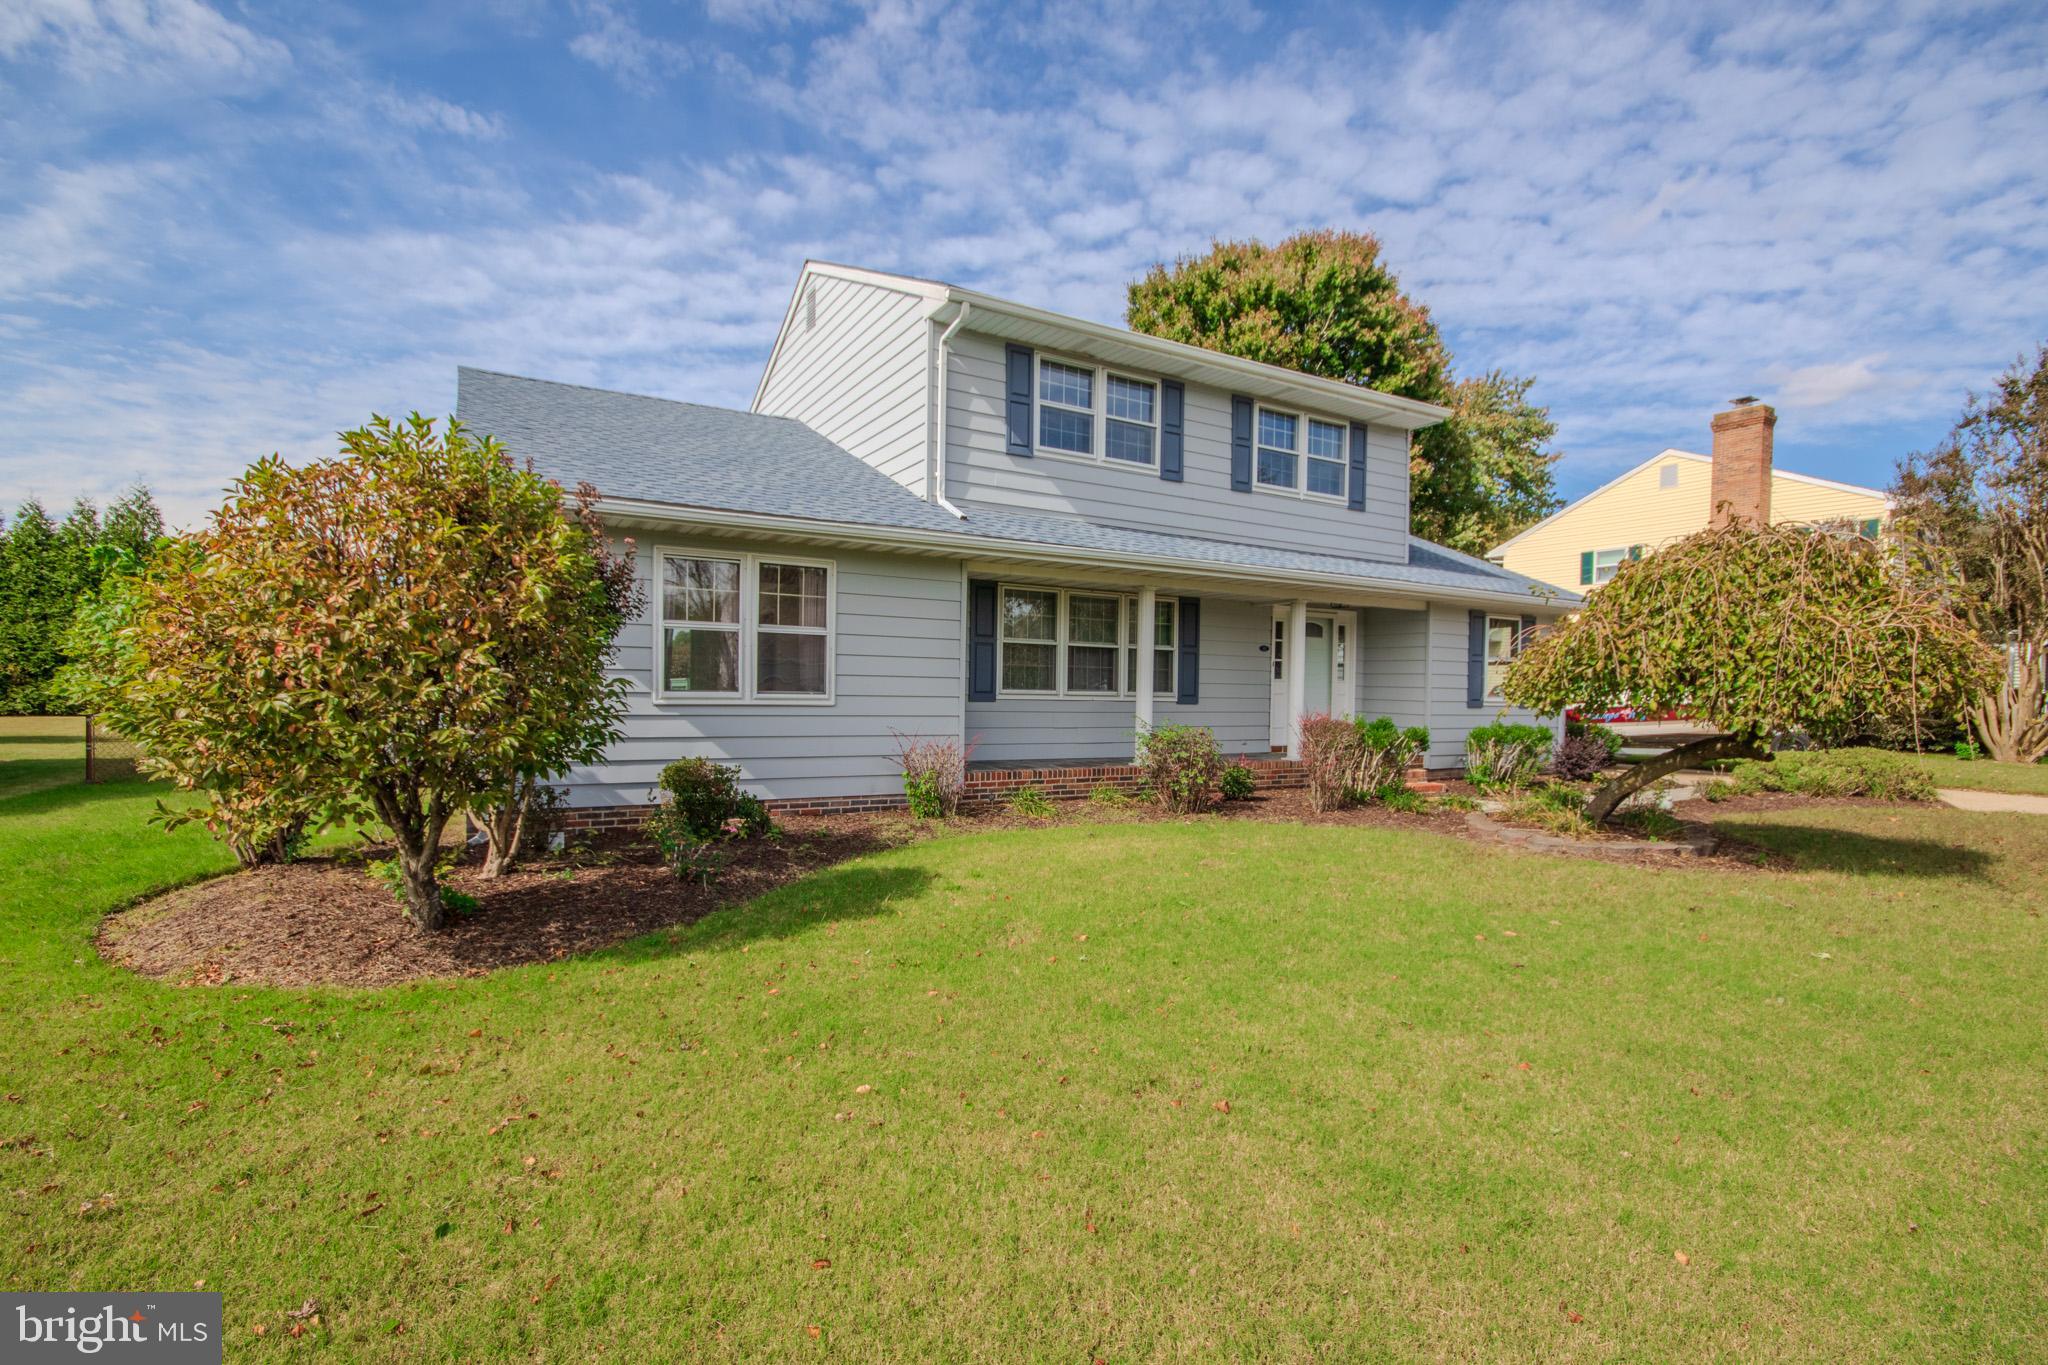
left=598, top=495, right=1579, bottom=612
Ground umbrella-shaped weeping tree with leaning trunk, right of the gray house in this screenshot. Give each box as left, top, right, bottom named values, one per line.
left=1503, top=522, right=1997, bottom=821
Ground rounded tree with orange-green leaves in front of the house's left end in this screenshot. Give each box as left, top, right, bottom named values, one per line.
left=66, top=413, right=633, bottom=931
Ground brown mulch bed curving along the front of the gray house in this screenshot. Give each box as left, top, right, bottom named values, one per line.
left=98, top=784, right=1864, bottom=986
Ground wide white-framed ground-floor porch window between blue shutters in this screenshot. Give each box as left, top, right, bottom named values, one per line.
left=995, top=585, right=1180, bottom=696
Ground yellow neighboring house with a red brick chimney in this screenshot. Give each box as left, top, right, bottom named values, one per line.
left=1487, top=399, right=1890, bottom=591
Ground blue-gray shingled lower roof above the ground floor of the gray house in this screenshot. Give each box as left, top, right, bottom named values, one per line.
left=455, top=366, right=1573, bottom=606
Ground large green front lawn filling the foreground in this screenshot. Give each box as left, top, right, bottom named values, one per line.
left=0, top=782, right=2048, bottom=1361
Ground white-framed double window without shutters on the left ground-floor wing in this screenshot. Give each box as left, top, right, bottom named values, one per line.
left=655, top=551, right=834, bottom=702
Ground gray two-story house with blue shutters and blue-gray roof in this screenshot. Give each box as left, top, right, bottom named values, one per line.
left=457, top=262, right=1577, bottom=825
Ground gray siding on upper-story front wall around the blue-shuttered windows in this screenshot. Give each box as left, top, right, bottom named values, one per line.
left=942, top=332, right=1409, bottom=563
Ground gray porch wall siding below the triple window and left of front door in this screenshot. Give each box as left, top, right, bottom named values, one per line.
left=967, top=600, right=1272, bottom=761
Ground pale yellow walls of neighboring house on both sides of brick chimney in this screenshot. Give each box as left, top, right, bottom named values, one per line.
left=1487, top=444, right=1890, bottom=591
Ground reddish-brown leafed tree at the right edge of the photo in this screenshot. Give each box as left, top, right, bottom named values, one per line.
left=1892, top=346, right=2048, bottom=763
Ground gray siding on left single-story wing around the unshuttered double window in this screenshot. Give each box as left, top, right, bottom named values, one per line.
left=567, top=530, right=963, bottom=806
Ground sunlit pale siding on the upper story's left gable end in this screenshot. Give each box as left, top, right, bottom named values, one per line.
left=754, top=274, right=932, bottom=497
